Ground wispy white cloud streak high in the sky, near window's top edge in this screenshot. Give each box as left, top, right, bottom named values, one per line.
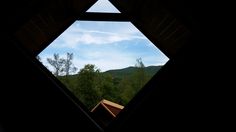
left=50, top=22, right=145, bottom=48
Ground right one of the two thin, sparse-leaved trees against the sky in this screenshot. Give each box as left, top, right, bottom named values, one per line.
left=63, top=53, right=77, bottom=76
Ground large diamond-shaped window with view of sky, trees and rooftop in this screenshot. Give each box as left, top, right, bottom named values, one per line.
left=37, top=0, right=169, bottom=126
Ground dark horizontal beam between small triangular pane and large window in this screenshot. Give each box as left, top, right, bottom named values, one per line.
left=78, top=12, right=129, bottom=21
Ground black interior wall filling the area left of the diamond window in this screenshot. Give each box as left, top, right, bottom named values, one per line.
left=0, top=0, right=102, bottom=132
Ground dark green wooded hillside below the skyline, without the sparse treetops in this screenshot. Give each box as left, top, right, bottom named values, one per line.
left=58, top=66, right=162, bottom=109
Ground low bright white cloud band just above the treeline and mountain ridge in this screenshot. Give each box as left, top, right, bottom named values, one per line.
left=38, top=50, right=169, bottom=72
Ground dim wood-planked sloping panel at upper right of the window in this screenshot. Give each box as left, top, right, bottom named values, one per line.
left=111, top=0, right=191, bottom=58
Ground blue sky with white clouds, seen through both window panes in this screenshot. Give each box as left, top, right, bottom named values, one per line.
left=39, top=0, right=168, bottom=71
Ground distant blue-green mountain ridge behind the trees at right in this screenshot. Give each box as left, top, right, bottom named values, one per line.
left=104, top=66, right=162, bottom=78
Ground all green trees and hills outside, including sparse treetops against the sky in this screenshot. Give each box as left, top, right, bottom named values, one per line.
left=43, top=53, right=161, bottom=110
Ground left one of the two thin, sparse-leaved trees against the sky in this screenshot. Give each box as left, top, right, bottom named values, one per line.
left=47, top=53, right=65, bottom=77
